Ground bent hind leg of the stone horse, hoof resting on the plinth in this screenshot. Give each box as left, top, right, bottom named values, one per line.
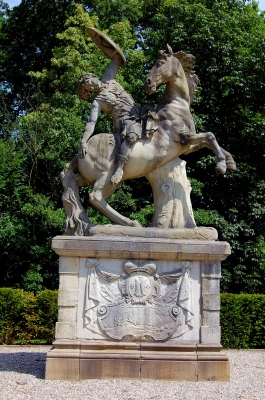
left=89, top=172, right=141, bottom=227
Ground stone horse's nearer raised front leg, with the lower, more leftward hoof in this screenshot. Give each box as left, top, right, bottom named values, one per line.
left=180, top=132, right=227, bottom=175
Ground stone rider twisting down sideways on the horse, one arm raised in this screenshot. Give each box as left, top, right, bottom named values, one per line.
left=78, top=34, right=158, bottom=184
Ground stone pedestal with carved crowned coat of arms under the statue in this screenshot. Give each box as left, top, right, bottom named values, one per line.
left=46, top=234, right=230, bottom=381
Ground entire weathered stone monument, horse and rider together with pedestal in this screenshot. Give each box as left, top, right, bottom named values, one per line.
left=46, top=28, right=233, bottom=381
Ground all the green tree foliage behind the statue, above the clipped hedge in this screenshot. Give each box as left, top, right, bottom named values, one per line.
left=0, top=0, right=265, bottom=293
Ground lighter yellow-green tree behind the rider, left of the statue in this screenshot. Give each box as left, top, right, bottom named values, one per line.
left=0, top=5, right=150, bottom=291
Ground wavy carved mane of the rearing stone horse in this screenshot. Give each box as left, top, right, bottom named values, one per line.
left=159, top=45, right=200, bottom=104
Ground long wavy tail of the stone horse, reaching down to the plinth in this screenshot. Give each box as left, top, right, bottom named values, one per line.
left=60, top=156, right=93, bottom=236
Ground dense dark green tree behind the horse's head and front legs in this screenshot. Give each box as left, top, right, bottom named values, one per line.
left=79, top=0, right=265, bottom=292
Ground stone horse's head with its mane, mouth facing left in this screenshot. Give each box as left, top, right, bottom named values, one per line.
left=144, top=45, right=200, bottom=103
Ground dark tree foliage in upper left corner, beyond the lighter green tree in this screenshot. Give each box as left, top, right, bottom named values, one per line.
left=0, top=0, right=74, bottom=122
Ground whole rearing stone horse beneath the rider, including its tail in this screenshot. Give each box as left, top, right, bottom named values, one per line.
left=61, top=46, right=236, bottom=235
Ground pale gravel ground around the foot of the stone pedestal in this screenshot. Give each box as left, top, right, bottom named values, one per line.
left=0, top=346, right=265, bottom=400
